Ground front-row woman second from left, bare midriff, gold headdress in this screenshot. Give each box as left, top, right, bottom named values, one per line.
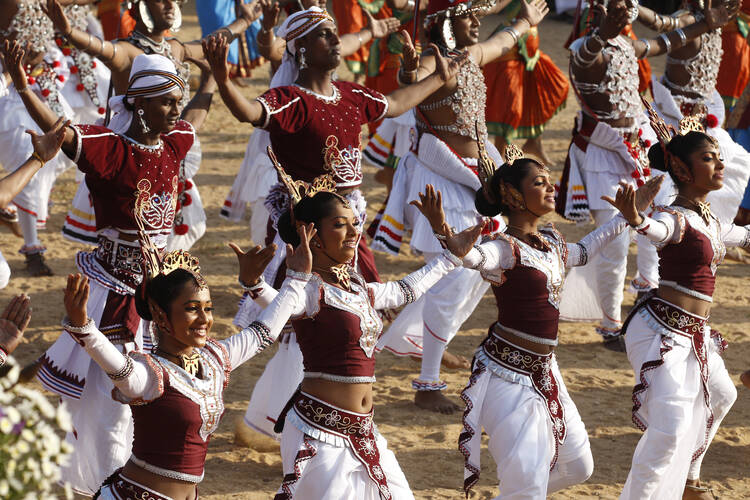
left=248, top=155, right=481, bottom=500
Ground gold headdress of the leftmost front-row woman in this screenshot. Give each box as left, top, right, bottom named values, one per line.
left=133, top=179, right=207, bottom=290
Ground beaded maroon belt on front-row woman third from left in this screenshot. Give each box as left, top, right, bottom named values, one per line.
left=482, top=332, right=566, bottom=469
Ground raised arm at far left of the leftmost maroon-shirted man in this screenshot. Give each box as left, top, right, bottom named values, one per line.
left=2, top=40, right=75, bottom=154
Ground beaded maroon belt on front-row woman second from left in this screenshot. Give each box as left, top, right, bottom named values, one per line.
left=293, top=391, right=393, bottom=500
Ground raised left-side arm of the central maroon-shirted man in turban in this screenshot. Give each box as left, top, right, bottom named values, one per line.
left=203, top=37, right=265, bottom=126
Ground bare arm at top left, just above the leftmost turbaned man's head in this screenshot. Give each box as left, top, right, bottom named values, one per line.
left=42, top=0, right=132, bottom=72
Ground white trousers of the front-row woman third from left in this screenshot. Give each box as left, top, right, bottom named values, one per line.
left=479, top=362, right=594, bottom=500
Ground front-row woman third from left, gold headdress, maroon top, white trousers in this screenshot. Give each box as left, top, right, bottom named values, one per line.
left=452, top=146, right=661, bottom=499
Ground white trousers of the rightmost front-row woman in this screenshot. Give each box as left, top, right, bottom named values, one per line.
left=620, top=310, right=737, bottom=500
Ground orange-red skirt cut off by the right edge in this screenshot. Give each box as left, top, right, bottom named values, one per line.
left=716, top=20, right=750, bottom=108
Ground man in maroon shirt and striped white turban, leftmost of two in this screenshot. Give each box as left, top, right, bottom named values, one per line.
left=5, top=39, right=216, bottom=495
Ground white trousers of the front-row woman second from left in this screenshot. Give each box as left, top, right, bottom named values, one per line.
left=279, top=424, right=414, bottom=500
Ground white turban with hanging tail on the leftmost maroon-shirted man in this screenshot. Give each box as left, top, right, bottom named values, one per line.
left=109, top=54, right=185, bottom=134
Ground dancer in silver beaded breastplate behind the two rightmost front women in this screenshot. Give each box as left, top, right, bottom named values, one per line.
left=558, top=0, right=729, bottom=342
